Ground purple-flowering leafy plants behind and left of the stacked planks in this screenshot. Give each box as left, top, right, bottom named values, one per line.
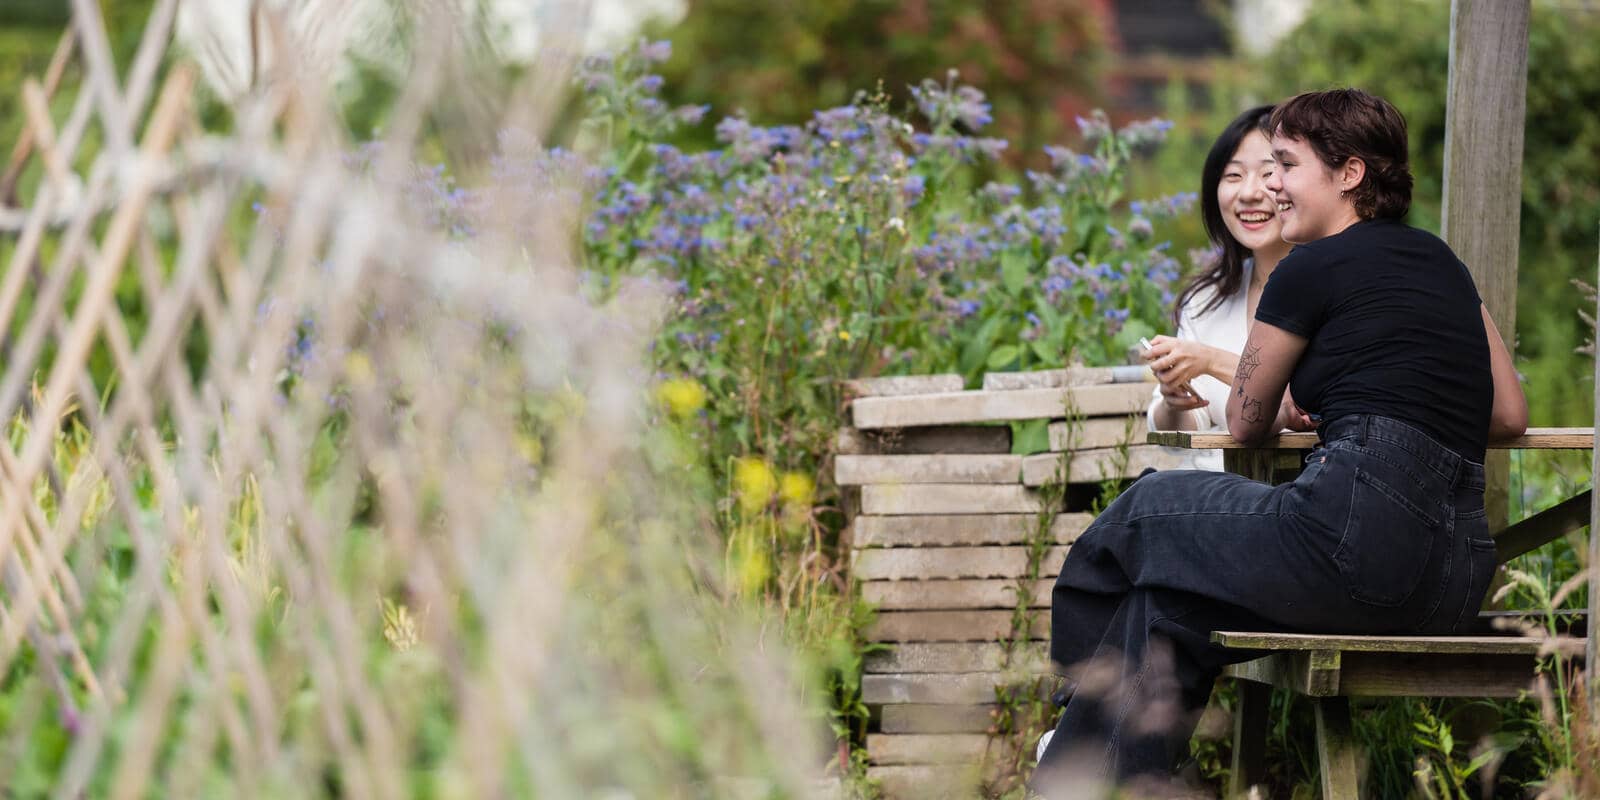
left=569, top=42, right=1194, bottom=675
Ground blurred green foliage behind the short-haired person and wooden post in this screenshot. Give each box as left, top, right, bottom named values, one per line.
left=1258, top=0, right=1600, bottom=426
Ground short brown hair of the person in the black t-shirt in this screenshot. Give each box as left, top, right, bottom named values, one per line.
left=1267, top=90, right=1411, bottom=219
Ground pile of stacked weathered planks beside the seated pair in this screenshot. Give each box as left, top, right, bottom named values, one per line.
left=835, top=368, right=1173, bottom=798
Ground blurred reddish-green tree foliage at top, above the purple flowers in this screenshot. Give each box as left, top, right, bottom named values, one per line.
left=653, top=0, right=1107, bottom=162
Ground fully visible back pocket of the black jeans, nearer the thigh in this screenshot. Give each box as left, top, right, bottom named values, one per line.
left=1333, top=467, right=1442, bottom=608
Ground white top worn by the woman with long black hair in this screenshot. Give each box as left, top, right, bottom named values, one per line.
left=1144, top=258, right=1256, bottom=472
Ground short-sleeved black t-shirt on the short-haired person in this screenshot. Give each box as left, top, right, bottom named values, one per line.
left=1256, top=219, right=1494, bottom=461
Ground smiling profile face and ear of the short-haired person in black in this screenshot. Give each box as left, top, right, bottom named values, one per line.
left=1266, top=134, right=1365, bottom=245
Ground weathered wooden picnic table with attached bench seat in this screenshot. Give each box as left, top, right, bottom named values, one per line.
left=1149, top=427, right=1594, bottom=800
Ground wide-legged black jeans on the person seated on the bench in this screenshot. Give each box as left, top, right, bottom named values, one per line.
left=1037, top=416, right=1496, bottom=792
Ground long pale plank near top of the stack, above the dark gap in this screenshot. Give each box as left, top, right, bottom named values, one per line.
left=850, top=384, right=1150, bottom=429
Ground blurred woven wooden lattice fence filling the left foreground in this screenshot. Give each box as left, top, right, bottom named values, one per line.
left=0, top=0, right=822, bottom=797
